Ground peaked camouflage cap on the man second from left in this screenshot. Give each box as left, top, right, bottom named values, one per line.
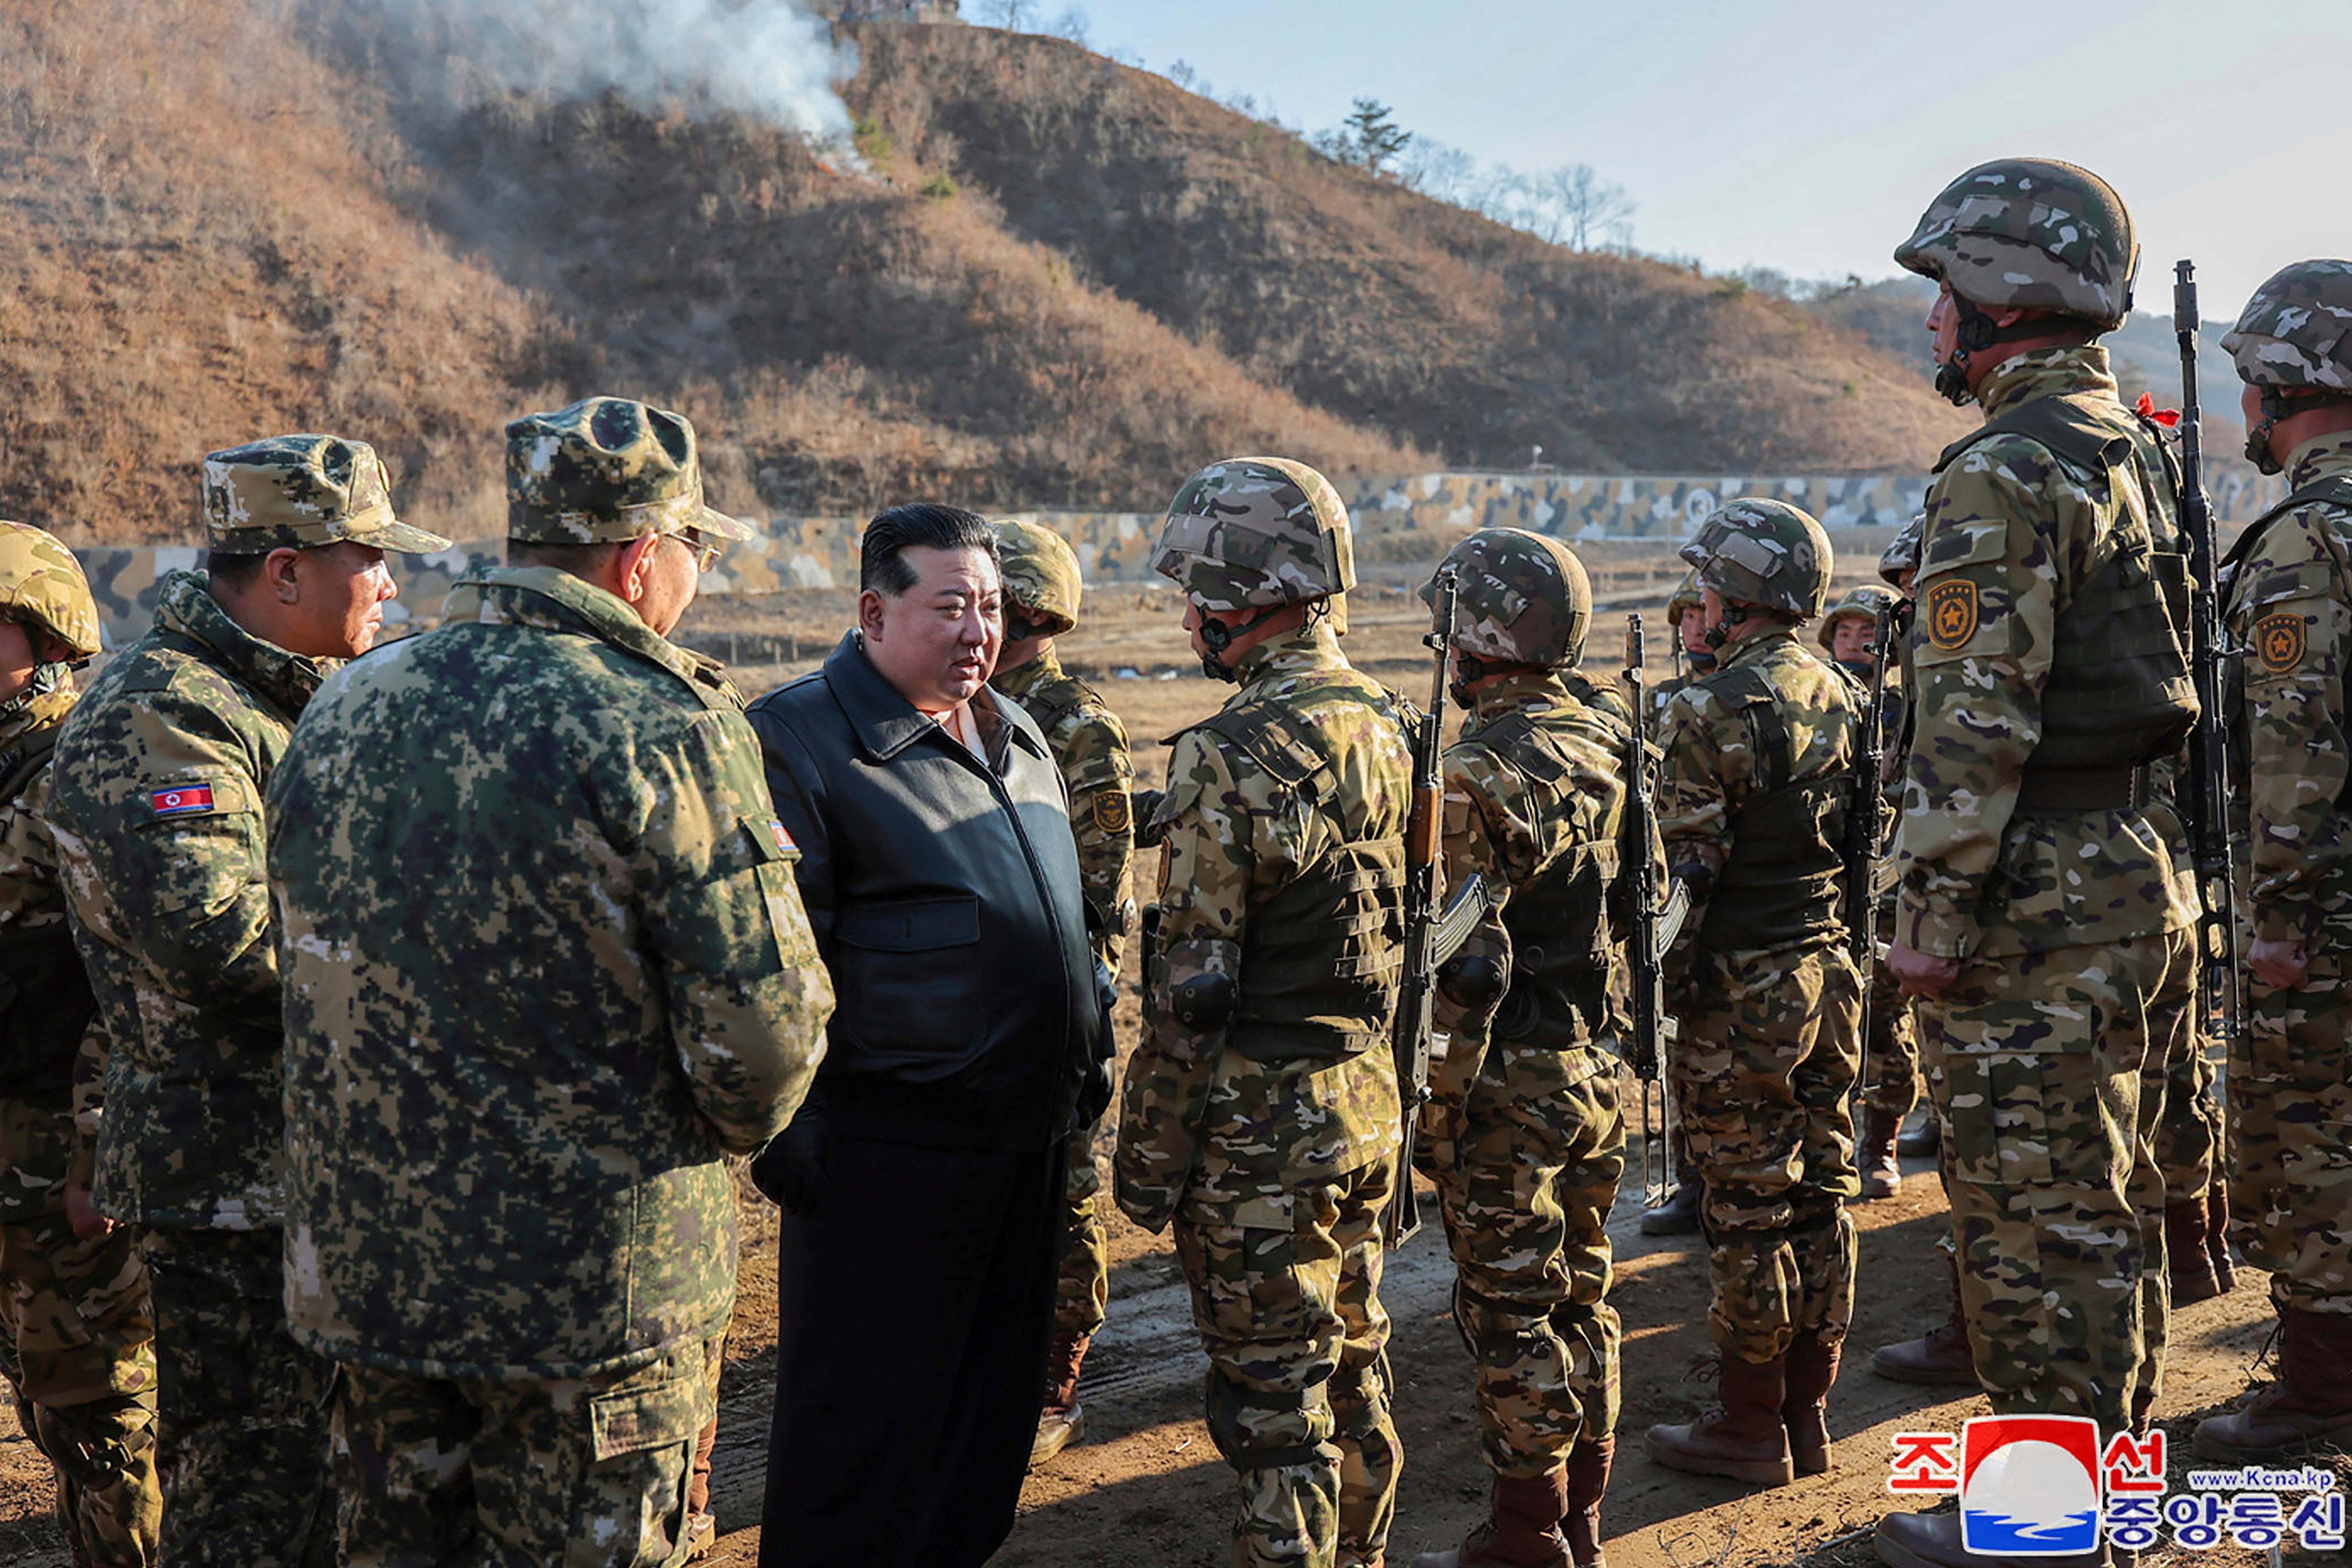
left=202, top=435, right=449, bottom=555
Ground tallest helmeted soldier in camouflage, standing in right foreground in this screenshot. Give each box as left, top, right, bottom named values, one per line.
left=1877, top=160, right=2197, bottom=1568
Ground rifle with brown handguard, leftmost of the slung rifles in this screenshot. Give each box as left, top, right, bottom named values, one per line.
left=1381, top=567, right=1475, bottom=1246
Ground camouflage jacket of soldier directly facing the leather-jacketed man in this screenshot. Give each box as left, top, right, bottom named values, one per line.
left=1115, top=625, right=1411, bottom=1229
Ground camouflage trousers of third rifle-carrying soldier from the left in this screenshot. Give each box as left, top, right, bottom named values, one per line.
left=1672, top=945, right=1863, bottom=1361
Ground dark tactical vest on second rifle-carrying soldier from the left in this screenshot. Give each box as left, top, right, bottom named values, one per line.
left=1475, top=713, right=1625, bottom=1051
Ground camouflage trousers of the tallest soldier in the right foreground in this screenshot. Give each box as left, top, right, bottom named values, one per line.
left=1919, top=933, right=2187, bottom=1432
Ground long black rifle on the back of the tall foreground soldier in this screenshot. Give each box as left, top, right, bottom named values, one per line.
left=2173, top=261, right=2239, bottom=1039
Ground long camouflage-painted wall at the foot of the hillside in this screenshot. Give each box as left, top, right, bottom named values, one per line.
left=77, top=472, right=2284, bottom=647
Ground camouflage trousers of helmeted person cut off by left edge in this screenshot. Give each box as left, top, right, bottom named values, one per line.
left=0, top=1213, right=162, bottom=1568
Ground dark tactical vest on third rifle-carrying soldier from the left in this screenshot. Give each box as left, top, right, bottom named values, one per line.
left=1698, top=665, right=1853, bottom=952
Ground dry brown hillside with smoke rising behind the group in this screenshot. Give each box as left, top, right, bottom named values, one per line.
left=0, top=0, right=1950, bottom=541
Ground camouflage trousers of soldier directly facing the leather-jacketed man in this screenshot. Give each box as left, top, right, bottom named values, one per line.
left=1174, top=1162, right=1404, bottom=1568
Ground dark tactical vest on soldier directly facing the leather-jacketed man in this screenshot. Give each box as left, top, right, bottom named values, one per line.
left=1202, top=693, right=1404, bottom=1063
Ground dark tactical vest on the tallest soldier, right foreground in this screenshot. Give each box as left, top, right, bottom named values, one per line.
left=1936, top=397, right=2197, bottom=811
